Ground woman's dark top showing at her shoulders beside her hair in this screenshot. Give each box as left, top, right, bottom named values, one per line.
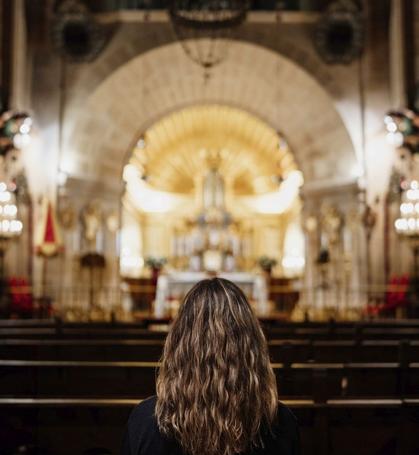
left=122, top=396, right=300, bottom=455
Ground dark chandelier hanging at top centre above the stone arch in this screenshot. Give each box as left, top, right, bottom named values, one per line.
left=169, top=0, right=250, bottom=76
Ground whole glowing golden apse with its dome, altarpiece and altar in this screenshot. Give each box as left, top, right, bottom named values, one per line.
left=121, top=105, right=304, bottom=312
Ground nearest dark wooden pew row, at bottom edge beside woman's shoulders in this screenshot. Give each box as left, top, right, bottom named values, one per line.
left=0, top=397, right=419, bottom=455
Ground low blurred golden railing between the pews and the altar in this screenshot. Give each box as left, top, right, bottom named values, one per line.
left=0, top=282, right=416, bottom=321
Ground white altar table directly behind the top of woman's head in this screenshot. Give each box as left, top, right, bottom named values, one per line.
left=154, top=272, right=268, bottom=317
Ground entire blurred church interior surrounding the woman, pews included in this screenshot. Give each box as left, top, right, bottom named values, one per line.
left=0, top=0, right=419, bottom=455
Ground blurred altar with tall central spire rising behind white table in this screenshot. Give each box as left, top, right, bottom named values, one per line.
left=127, top=138, right=298, bottom=317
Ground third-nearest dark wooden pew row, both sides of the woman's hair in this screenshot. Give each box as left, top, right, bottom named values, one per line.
left=0, top=339, right=419, bottom=364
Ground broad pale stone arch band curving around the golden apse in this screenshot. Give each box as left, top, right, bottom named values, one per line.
left=64, top=42, right=358, bottom=192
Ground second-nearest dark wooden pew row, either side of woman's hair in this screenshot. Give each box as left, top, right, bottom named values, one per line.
left=0, top=360, right=419, bottom=402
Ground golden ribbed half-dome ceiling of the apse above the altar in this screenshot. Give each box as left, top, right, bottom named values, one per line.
left=131, top=105, right=297, bottom=195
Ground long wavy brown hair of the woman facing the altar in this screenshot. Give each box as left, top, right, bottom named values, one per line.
left=156, top=278, right=278, bottom=455
